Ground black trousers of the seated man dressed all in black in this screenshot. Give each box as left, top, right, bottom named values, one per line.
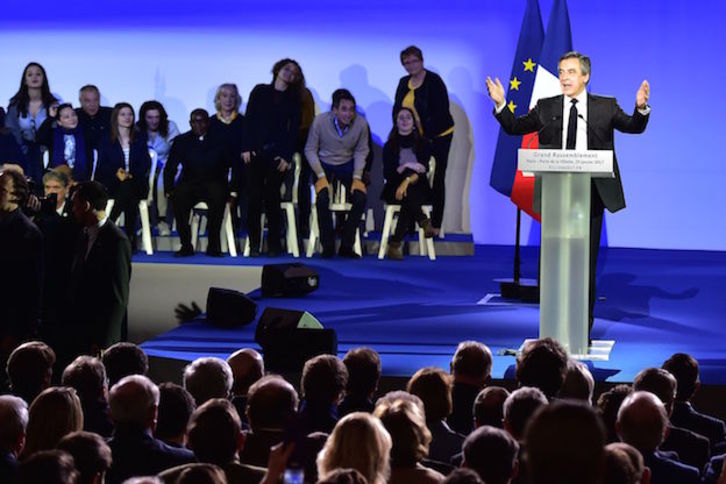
left=172, top=181, right=227, bottom=252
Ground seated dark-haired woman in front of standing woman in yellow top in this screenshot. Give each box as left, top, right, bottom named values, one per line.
left=381, top=108, right=435, bottom=260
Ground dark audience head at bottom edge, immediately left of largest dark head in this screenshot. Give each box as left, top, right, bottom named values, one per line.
left=462, top=425, right=519, bottom=484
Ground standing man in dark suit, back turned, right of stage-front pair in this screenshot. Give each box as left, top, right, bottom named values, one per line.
left=67, top=181, right=131, bottom=356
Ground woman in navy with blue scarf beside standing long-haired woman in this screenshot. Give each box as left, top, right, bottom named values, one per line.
left=36, top=103, right=93, bottom=182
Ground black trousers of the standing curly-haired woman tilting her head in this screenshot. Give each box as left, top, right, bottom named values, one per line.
left=247, top=156, right=285, bottom=251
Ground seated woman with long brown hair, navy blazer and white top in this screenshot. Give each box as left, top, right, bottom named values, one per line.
left=95, top=103, right=151, bottom=249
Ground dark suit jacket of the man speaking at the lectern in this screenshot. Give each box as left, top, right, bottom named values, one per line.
left=496, top=94, right=649, bottom=212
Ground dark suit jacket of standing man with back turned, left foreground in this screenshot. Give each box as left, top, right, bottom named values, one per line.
left=67, top=220, right=131, bottom=351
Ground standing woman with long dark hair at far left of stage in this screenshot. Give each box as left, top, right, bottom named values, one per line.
left=5, top=62, right=58, bottom=186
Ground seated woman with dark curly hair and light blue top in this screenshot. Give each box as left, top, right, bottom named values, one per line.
left=136, top=101, right=179, bottom=235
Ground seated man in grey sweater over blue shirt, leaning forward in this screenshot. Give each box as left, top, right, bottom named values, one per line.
left=305, top=89, right=369, bottom=258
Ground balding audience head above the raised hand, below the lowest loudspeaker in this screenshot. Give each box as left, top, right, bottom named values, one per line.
left=247, top=375, right=298, bottom=432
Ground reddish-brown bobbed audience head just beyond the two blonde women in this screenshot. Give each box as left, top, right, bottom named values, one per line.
left=406, top=367, right=453, bottom=422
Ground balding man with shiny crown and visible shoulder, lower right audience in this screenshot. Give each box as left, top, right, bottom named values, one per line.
left=615, top=391, right=700, bottom=484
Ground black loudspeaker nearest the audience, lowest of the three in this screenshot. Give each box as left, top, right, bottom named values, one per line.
left=255, top=308, right=338, bottom=372
